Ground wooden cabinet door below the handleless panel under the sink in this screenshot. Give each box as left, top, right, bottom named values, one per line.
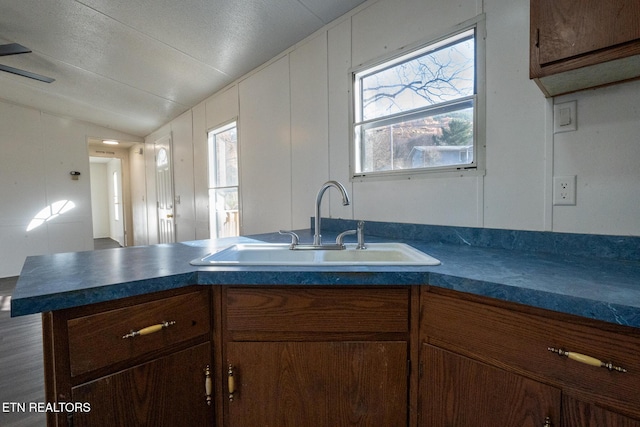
left=227, top=341, right=407, bottom=427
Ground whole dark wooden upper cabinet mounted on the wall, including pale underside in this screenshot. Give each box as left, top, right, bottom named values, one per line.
left=529, top=0, right=640, bottom=97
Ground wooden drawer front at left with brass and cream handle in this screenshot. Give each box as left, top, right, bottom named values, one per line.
left=67, top=288, right=210, bottom=376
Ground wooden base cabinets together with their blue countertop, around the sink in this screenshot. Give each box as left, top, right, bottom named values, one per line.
left=12, top=219, right=640, bottom=426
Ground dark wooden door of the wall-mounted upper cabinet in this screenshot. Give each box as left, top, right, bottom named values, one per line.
left=532, top=0, right=640, bottom=65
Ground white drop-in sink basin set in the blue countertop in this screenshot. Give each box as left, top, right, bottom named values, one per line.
left=191, top=243, right=440, bottom=266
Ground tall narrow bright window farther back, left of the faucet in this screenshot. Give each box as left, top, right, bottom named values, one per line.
left=208, top=122, right=240, bottom=238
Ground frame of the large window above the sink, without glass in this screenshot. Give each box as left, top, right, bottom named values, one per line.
left=348, top=14, right=486, bottom=181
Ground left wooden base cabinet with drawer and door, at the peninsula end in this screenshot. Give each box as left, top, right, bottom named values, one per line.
left=43, top=287, right=213, bottom=426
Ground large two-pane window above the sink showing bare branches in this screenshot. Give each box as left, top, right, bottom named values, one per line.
left=352, top=21, right=483, bottom=178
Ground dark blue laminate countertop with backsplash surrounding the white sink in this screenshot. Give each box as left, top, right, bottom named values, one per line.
left=11, top=219, right=640, bottom=328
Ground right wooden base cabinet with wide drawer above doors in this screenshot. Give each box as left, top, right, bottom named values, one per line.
left=420, top=289, right=640, bottom=427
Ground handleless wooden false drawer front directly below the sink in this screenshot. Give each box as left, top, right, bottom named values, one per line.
left=226, top=287, right=409, bottom=333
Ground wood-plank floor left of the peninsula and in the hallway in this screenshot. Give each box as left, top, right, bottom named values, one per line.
left=0, top=239, right=120, bottom=427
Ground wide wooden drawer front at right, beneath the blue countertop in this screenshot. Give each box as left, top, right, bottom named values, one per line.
left=421, top=293, right=640, bottom=416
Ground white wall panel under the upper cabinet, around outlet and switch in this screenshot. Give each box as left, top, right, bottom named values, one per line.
left=553, top=85, right=640, bottom=235
